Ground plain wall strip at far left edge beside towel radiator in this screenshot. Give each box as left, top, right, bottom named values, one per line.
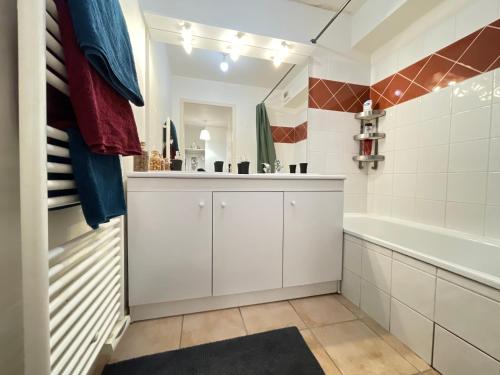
left=0, top=1, right=24, bottom=374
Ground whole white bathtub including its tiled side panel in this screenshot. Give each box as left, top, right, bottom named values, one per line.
left=341, top=214, right=500, bottom=375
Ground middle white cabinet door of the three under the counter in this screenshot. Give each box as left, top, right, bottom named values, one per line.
left=213, top=192, right=283, bottom=296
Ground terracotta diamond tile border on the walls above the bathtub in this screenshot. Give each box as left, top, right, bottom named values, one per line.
left=309, top=19, right=500, bottom=113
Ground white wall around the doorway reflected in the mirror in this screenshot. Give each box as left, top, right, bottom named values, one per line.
left=172, top=76, right=268, bottom=172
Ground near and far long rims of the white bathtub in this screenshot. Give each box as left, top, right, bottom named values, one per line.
left=344, top=214, right=500, bottom=290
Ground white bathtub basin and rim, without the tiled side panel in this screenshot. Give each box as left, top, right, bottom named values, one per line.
left=344, top=214, right=500, bottom=289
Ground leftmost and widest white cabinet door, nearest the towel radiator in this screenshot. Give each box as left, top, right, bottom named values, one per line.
left=128, top=192, right=212, bottom=306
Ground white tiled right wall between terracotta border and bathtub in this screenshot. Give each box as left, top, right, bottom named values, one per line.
left=368, top=69, right=500, bottom=238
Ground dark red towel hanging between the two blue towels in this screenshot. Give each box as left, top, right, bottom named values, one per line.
left=56, top=0, right=141, bottom=156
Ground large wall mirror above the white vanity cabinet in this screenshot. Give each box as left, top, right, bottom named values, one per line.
left=153, top=18, right=308, bottom=173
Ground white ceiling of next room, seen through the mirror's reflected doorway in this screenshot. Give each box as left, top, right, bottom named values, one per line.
left=183, top=103, right=232, bottom=128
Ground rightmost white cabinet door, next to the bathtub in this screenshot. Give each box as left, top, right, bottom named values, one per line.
left=283, top=192, right=343, bottom=287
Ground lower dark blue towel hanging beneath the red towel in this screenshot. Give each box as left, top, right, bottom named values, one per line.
left=67, top=128, right=127, bottom=229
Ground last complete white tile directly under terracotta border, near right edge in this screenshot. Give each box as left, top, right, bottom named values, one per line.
left=452, top=72, right=493, bottom=113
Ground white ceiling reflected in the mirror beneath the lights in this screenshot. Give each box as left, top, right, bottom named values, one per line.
left=167, top=44, right=300, bottom=88
